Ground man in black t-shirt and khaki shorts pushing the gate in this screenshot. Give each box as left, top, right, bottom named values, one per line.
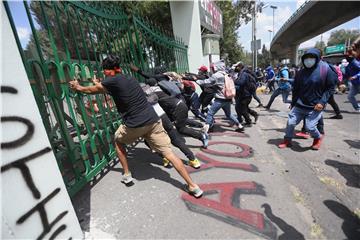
left=69, top=55, right=203, bottom=198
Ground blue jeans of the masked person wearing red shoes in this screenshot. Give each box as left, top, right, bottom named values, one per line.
left=285, top=107, right=322, bottom=140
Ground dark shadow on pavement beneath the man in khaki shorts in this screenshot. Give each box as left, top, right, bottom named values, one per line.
left=110, top=147, right=184, bottom=190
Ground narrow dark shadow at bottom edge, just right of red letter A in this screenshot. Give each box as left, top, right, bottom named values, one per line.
left=261, top=203, right=305, bottom=240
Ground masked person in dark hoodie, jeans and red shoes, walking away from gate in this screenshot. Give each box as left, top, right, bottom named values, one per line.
left=279, top=48, right=337, bottom=150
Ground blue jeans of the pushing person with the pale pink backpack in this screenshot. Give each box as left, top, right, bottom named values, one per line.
left=206, top=98, right=239, bottom=127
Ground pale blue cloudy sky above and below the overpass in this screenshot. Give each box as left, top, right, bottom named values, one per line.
left=237, top=0, right=360, bottom=52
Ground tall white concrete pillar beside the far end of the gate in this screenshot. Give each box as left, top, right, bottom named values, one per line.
left=170, top=1, right=204, bottom=72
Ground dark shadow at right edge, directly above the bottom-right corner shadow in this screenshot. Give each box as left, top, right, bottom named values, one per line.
left=325, top=159, right=360, bottom=188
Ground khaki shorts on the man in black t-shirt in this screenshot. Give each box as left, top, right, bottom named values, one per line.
left=115, top=120, right=172, bottom=156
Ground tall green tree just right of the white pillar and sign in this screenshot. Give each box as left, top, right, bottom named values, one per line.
left=216, top=0, right=254, bottom=63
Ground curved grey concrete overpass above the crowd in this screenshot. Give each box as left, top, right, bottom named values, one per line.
left=270, top=1, right=360, bottom=63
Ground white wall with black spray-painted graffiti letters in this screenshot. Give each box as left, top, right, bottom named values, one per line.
left=0, top=4, right=83, bottom=239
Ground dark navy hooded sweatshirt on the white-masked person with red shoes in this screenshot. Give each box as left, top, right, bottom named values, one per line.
left=291, top=48, right=337, bottom=109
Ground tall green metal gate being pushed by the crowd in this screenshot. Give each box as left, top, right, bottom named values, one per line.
left=4, top=1, right=188, bottom=196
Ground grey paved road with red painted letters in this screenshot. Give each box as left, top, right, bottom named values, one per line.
left=73, top=95, right=360, bottom=239
